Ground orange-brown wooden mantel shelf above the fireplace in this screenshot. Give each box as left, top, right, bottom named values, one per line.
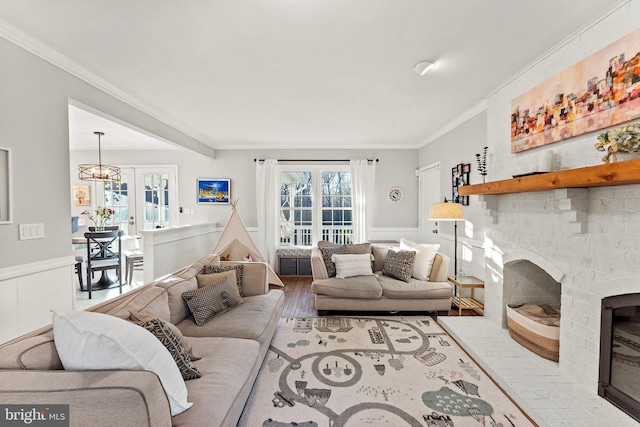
left=458, top=159, right=640, bottom=196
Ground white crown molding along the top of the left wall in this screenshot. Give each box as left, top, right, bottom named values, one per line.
left=0, top=19, right=213, bottom=148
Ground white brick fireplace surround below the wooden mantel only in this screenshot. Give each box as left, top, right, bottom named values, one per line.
left=483, top=185, right=640, bottom=390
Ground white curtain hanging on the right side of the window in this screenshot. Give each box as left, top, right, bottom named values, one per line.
left=349, top=159, right=376, bottom=243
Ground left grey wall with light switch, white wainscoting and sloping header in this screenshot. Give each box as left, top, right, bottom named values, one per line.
left=0, top=39, right=214, bottom=340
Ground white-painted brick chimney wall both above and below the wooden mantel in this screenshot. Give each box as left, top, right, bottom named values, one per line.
left=478, top=0, right=640, bottom=392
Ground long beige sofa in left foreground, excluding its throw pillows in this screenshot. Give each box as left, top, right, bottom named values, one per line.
left=0, top=255, right=284, bottom=427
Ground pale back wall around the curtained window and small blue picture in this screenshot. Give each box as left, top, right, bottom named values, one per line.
left=70, top=149, right=418, bottom=232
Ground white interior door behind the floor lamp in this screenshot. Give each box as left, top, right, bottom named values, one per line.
left=418, top=162, right=442, bottom=243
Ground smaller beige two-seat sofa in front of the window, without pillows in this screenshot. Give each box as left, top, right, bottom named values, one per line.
left=311, top=242, right=452, bottom=314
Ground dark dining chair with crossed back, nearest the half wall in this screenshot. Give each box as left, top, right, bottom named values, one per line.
left=84, top=230, right=123, bottom=299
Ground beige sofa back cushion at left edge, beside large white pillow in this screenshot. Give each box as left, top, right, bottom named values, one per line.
left=0, top=333, right=64, bottom=370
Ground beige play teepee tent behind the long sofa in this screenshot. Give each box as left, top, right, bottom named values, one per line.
left=211, top=200, right=284, bottom=286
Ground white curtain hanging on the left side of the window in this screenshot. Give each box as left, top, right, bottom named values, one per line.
left=256, top=159, right=280, bottom=267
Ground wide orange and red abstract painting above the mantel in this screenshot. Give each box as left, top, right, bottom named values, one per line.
left=511, top=28, right=640, bottom=153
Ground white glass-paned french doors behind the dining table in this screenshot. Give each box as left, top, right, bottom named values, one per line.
left=97, top=166, right=178, bottom=235
